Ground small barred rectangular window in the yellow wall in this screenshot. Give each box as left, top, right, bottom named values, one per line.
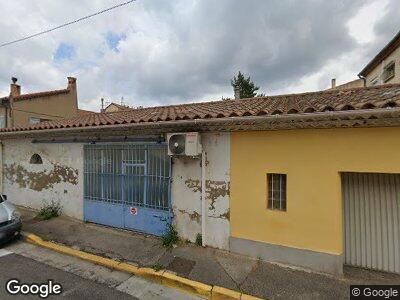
left=267, top=173, right=287, bottom=211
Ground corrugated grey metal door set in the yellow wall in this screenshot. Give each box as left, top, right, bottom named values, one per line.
left=342, top=173, right=400, bottom=273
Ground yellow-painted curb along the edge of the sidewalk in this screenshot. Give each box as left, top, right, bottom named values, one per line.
left=22, top=232, right=261, bottom=300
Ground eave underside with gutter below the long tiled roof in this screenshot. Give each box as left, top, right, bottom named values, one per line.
left=0, top=108, right=400, bottom=140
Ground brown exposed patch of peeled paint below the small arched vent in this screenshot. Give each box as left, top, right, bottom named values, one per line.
left=4, top=163, right=78, bottom=192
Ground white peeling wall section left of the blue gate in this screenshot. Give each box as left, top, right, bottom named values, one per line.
left=3, top=139, right=83, bottom=220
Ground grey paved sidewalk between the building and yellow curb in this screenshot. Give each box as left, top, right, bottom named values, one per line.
left=20, top=208, right=400, bottom=299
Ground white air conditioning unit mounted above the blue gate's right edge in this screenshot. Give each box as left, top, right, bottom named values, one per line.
left=167, top=132, right=202, bottom=157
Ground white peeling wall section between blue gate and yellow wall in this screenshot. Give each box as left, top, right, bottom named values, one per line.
left=171, top=133, right=230, bottom=249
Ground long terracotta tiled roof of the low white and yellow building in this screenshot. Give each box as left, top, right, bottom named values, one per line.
left=0, top=84, right=400, bottom=132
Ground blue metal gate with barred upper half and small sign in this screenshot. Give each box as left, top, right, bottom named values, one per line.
left=84, top=144, right=172, bottom=235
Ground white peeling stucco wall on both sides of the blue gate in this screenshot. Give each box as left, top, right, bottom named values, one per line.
left=3, top=133, right=230, bottom=249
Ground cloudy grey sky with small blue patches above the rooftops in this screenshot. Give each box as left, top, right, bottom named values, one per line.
left=0, top=0, right=400, bottom=110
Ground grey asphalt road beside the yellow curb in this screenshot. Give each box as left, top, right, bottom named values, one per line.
left=0, top=241, right=199, bottom=300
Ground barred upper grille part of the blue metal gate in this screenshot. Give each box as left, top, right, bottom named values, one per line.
left=84, top=144, right=171, bottom=210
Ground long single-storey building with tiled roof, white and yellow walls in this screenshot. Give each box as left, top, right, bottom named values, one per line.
left=0, top=85, right=400, bottom=274
